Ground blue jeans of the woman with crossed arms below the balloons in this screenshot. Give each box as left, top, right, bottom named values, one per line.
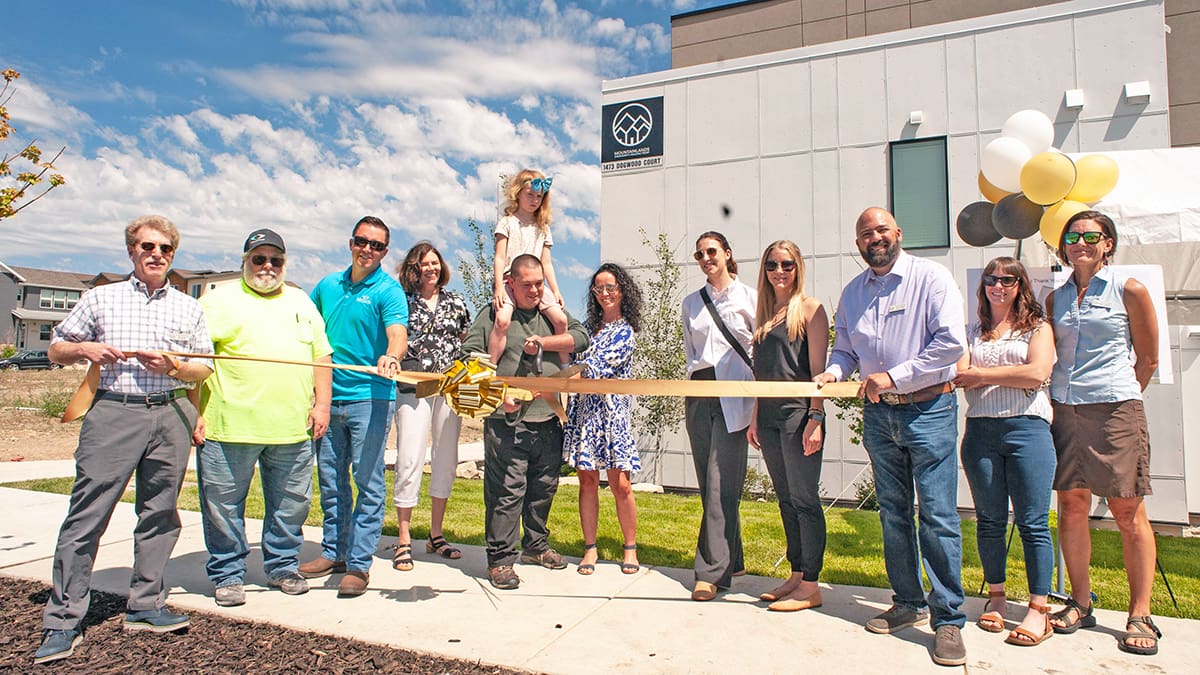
left=962, top=416, right=1057, bottom=596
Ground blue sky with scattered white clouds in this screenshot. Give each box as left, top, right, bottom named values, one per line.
left=0, top=0, right=721, bottom=311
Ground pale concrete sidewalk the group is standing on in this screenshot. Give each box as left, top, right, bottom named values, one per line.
left=0, top=462, right=1200, bottom=674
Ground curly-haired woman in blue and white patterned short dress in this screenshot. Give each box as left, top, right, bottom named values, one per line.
left=563, top=263, right=642, bottom=575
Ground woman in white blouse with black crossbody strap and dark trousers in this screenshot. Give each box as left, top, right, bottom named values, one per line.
left=683, top=232, right=757, bottom=601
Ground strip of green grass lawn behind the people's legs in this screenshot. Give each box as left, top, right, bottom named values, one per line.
left=6, top=472, right=1200, bottom=619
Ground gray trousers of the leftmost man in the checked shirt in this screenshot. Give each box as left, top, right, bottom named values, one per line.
left=43, top=399, right=196, bottom=631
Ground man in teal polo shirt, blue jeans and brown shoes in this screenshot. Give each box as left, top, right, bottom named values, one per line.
left=300, top=216, right=408, bottom=597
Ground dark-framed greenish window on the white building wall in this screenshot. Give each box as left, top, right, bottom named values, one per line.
left=888, top=136, right=950, bottom=249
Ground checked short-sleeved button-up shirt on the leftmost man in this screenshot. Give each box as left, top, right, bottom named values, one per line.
left=50, top=275, right=212, bottom=394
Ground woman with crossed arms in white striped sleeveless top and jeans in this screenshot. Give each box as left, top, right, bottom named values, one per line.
left=954, top=257, right=1056, bottom=646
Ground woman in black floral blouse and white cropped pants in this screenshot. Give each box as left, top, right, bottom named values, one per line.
left=392, top=241, right=470, bottom=572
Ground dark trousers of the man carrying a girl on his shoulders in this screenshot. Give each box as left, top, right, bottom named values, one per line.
left=484, top=418, right=563, bottom=567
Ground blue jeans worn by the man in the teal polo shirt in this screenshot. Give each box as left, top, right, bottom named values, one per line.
left=317, top=399, right=394, bottom=572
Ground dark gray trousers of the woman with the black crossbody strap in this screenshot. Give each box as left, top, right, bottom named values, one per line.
left=684, top=398, right=746, bottom=589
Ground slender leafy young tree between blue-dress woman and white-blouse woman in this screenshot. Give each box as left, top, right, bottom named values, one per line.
left=631, top=228, right=688, bottom=482
